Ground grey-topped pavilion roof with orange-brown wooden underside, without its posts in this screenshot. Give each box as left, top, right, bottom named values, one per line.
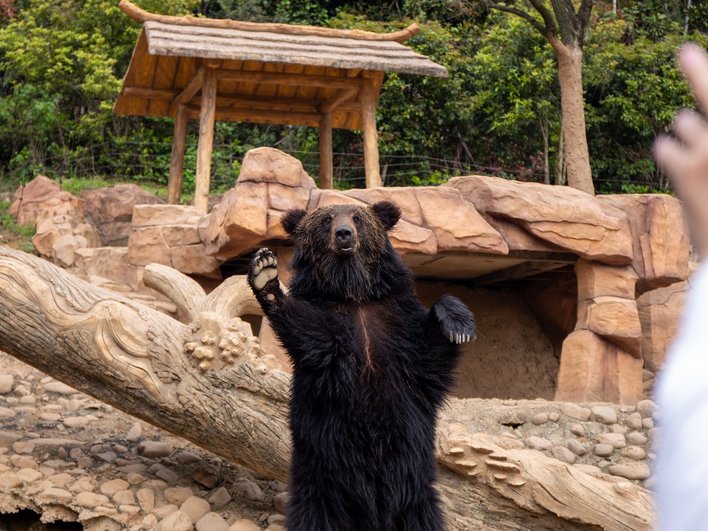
left=115, top=0, right=447, bottom=129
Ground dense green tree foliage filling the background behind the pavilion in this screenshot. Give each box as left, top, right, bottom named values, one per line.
left=0, top=0, right=708, bottom=192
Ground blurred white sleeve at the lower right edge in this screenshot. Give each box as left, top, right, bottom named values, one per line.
left=655, top=262, right=708, bottom=531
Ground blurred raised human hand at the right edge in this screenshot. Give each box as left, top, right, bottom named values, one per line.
left=654, top=44, right=708, bottom=259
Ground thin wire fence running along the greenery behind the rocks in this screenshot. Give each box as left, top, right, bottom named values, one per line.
left=0, top=141, right=670, bottom=195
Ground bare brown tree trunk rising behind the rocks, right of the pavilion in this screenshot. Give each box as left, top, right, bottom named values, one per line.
left=551, top=40, right=595, bottom=194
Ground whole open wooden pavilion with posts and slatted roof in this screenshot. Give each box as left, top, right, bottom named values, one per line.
left=114, top=0, right=447, bottom=212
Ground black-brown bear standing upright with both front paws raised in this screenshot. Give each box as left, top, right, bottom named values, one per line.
left=247, top=201, right=475, bottom=531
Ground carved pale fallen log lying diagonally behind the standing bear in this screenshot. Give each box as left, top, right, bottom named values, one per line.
left=0, top=247, right=652, bottom=531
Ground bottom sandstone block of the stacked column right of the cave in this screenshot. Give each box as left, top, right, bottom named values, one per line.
left=555, top=330, right=643, bottom=406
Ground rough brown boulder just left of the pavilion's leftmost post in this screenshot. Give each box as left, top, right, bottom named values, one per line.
left=80, top=184, right=164, bottom=247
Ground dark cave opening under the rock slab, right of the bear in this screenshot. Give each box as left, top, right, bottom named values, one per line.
left=417, top=265, right=577, bottom=400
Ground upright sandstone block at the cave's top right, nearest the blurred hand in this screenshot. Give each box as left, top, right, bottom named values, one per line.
left=598, top=194, right=689, bottom=293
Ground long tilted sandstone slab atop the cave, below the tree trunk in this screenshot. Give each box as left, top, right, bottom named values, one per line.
left=447, top=175, right=633, bottom=265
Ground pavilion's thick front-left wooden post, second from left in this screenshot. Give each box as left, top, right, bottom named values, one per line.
left=194, top=69, right=216, bottom=214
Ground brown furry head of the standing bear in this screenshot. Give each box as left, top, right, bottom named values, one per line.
left=281, top=201, right=407, bottom=302
